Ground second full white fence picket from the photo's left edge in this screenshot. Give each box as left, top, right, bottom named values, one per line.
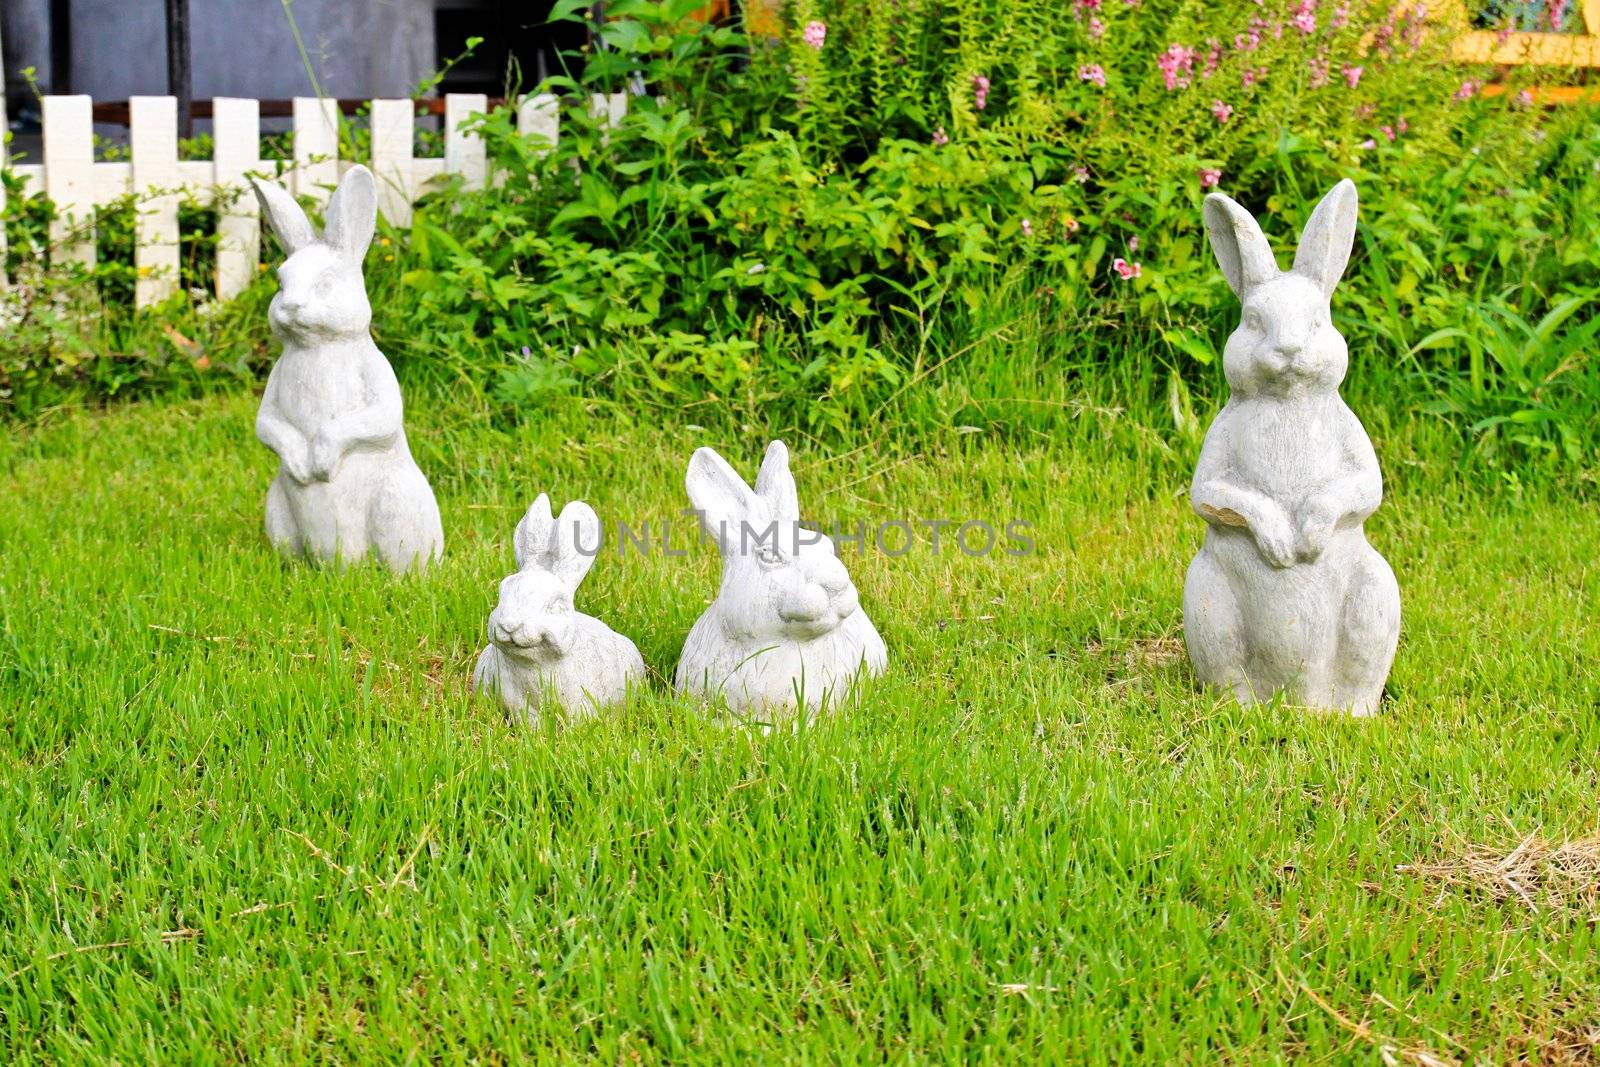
left=128, top=96, right=179, bottom=307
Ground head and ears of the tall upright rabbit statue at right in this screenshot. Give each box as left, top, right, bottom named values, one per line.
left=1205, top=179, right=1355, bottom=397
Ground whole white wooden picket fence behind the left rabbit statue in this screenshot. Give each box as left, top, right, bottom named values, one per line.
left=0, top=93, right=627, bottom=306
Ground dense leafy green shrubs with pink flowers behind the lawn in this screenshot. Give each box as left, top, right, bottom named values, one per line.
left=0, top=0, right=1600, bottom=477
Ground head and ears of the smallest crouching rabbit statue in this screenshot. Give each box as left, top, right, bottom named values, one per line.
left=490, top=493, right=600, bottom=664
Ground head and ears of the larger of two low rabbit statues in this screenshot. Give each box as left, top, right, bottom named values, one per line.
left=686, top=442, right=861, bottom=641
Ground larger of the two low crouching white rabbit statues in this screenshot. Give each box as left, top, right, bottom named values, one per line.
left=677, top=442, right=888, bottom=715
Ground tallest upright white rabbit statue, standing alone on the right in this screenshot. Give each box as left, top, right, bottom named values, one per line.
left=1184, top=181, right=1400, bottom=715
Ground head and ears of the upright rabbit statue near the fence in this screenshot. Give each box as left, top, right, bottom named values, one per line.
left=254, top=166, right=378, bottom=344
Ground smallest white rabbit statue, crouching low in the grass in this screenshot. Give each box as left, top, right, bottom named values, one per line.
left=472, top=493, right=645, bottom=720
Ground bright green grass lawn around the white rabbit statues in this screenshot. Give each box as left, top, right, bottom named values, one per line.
left=0, top=395, right=1600, bottom=1064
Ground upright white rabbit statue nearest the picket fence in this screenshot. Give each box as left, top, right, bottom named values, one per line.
left=254, top=166, right=445, bottom=571
